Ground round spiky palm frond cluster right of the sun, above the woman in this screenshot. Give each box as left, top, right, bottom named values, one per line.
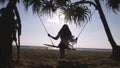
left=62, top=5, right=91, bottom=25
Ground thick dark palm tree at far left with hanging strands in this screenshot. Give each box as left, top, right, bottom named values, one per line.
left=0, top=0, right=21, bottom=68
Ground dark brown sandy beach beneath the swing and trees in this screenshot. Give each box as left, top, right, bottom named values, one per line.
left=13, top=48, right=120, bottom=68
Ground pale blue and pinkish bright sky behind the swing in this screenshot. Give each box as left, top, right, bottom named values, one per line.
left=0, top=2, right=120, bottom=49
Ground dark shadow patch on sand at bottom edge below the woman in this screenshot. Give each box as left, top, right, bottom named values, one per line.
left=57, top=61, right=88, bottom=68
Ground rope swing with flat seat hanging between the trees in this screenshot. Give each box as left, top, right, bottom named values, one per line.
left=37, top=10, right=95, bottom=50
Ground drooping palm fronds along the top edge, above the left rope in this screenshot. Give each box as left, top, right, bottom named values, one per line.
left=23, top=0, right=56, bottom=14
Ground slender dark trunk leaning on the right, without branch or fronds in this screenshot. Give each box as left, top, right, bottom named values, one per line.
left=95, top=0, right=120, bottom=60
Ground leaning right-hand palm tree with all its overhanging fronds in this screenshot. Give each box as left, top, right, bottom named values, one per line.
left=2, top=0, right=120, bottom=60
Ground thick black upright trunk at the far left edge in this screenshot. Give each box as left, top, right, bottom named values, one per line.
left=0, top=0, right=19, bottom=68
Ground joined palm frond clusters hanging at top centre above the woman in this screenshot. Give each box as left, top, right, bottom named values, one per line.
left=23, top=0, right=91, bottom=25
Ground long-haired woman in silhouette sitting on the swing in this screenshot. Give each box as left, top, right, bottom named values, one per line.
left=48, top=24, right=77, bottom=58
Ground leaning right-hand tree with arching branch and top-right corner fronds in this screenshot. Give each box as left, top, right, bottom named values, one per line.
left=66, top=0, right=120, bottom=60
